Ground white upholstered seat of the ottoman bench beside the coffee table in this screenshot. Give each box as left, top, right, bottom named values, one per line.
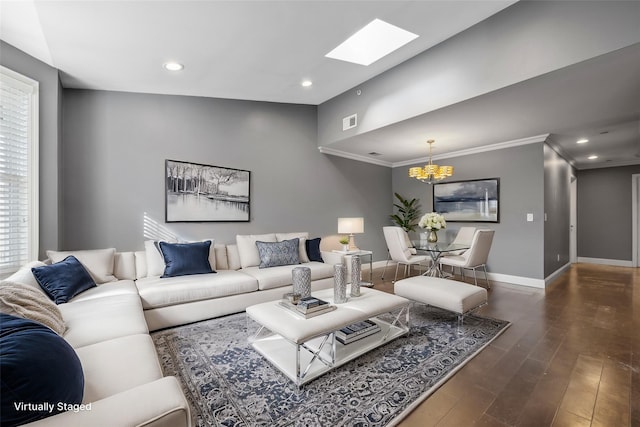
left=393, top=276, right=487, bottom=316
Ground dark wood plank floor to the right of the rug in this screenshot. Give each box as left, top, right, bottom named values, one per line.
left=374, top=264, right=640, bottom=427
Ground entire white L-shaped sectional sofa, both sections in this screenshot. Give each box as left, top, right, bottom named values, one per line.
left=1, top=233, right=342, bottom=427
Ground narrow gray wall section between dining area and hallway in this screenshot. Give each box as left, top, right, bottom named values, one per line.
left=544, top=144, right=573, bottom=277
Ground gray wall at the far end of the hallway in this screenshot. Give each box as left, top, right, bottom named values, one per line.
left=577, top=165, right=640, bottom=261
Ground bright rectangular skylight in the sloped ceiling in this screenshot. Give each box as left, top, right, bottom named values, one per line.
left=325, top=19, right=418, bottom=65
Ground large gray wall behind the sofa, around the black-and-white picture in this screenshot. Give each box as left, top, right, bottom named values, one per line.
left=62, top=90, right=391, bottom=259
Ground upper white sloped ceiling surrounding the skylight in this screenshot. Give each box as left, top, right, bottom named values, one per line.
left=0, top=0, right=515, bottom=105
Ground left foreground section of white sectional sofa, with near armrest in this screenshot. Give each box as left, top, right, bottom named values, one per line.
left=0, top=258, right=191, bottom=427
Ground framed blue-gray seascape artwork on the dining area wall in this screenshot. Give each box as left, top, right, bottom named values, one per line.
left=433, top=178, right=500, bottom=222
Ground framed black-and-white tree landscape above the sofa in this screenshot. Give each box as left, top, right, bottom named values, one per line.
left=164, top=160, right=251, bottom=222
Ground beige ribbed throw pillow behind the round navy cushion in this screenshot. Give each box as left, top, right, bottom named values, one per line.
left=0, top=280, right=66, bottom=335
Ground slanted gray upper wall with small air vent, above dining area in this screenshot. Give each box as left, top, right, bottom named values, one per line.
left=318, top=1, right=640, bottom=146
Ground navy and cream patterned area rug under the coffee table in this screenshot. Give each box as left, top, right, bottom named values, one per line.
left=151, top=306, right=509, bottom=427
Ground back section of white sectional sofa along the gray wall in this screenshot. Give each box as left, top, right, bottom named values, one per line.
left=132, top=233, right=342, bottom=331
